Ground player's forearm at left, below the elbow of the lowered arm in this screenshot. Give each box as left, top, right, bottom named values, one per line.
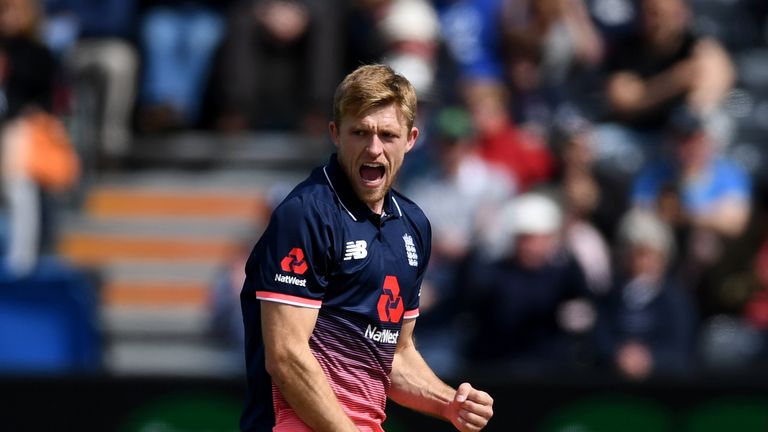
left=269, top=347, right=357, bottom=432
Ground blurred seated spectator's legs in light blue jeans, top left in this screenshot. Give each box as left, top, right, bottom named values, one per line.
left=138, top=0, right=227, bottom=132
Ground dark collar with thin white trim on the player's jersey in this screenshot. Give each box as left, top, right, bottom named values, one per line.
left=323, top=153, right=403, bottom=221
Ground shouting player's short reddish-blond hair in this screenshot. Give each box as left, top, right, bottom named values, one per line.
left=333, top=64, right=416, bottom=129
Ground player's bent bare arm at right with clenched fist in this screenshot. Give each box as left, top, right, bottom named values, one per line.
left=388, top=320, right=493, bottom=431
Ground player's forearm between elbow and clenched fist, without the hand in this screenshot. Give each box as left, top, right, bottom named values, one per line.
left=388, top=346, right=456, bottom=418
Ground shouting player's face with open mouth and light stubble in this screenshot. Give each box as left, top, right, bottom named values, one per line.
left=329, top=104, right=419, bottom=214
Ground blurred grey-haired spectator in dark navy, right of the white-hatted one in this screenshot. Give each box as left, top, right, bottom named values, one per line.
left=597, top=210, right=696, bottom=380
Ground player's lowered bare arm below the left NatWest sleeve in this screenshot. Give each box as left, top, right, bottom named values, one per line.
left=261, top=301, right=357, bottom=432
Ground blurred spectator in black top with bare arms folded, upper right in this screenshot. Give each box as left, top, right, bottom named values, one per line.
left=595, top=0, right=734, bottom=175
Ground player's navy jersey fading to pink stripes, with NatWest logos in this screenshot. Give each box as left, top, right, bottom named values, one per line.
left=240, top=155, right=431, bottom=432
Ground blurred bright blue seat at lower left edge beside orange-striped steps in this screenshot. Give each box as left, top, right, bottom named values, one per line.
left=0, top=258, right=101, bottom=374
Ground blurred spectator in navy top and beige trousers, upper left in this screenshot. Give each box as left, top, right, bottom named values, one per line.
left=46, top=0, right=139, bottom=158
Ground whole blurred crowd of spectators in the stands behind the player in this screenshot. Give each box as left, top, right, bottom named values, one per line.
left=0, top=0, right=768, bottom=379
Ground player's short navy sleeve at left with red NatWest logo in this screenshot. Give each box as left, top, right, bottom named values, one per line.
left=245, top=196, right=331, bottom=309
